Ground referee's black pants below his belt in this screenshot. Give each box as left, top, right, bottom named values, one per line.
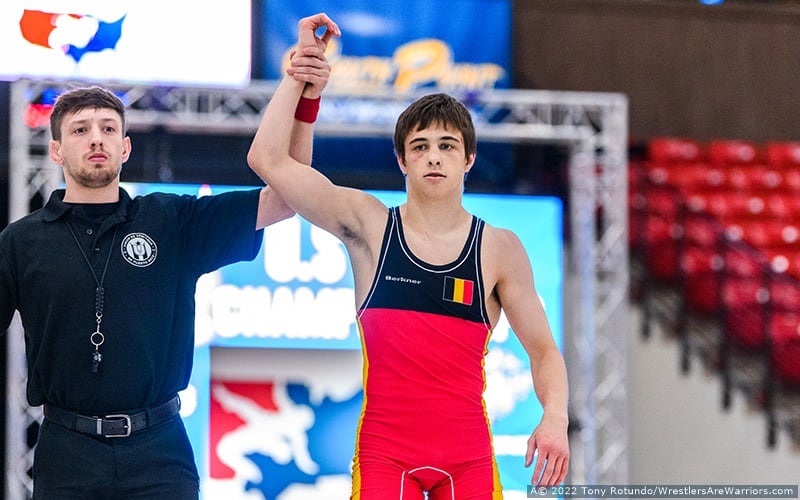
left=33, top=415, right=200, bottom=500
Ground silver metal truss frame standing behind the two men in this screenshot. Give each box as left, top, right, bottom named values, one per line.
left=5, top=81, right=629, bottom=500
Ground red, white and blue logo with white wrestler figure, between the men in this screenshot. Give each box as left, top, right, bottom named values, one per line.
left=209, top=376, right=363, bottom=500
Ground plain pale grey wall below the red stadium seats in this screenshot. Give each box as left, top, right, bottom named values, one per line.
left=629, top=307, right=800, bottom=485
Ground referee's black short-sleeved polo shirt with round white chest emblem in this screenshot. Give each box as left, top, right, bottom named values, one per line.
left=0, top=189, right=263, bottom=414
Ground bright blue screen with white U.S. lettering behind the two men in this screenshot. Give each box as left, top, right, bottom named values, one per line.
left=123, top=183, right=564, bottom=500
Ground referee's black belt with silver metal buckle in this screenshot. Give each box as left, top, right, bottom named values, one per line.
left=44, top=396, right=181, bottom=437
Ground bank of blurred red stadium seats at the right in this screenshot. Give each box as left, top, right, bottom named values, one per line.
left=629, top=137, right=800, bottom=446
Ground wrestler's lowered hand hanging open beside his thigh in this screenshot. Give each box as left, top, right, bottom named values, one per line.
left=525, top=415, right=569, bottom=486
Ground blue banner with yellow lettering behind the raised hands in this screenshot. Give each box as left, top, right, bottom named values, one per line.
left=263, top=0, right=511, bottom=92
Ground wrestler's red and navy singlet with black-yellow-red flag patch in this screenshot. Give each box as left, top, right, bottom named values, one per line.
left=352, top=207, right=502, bottom=500
